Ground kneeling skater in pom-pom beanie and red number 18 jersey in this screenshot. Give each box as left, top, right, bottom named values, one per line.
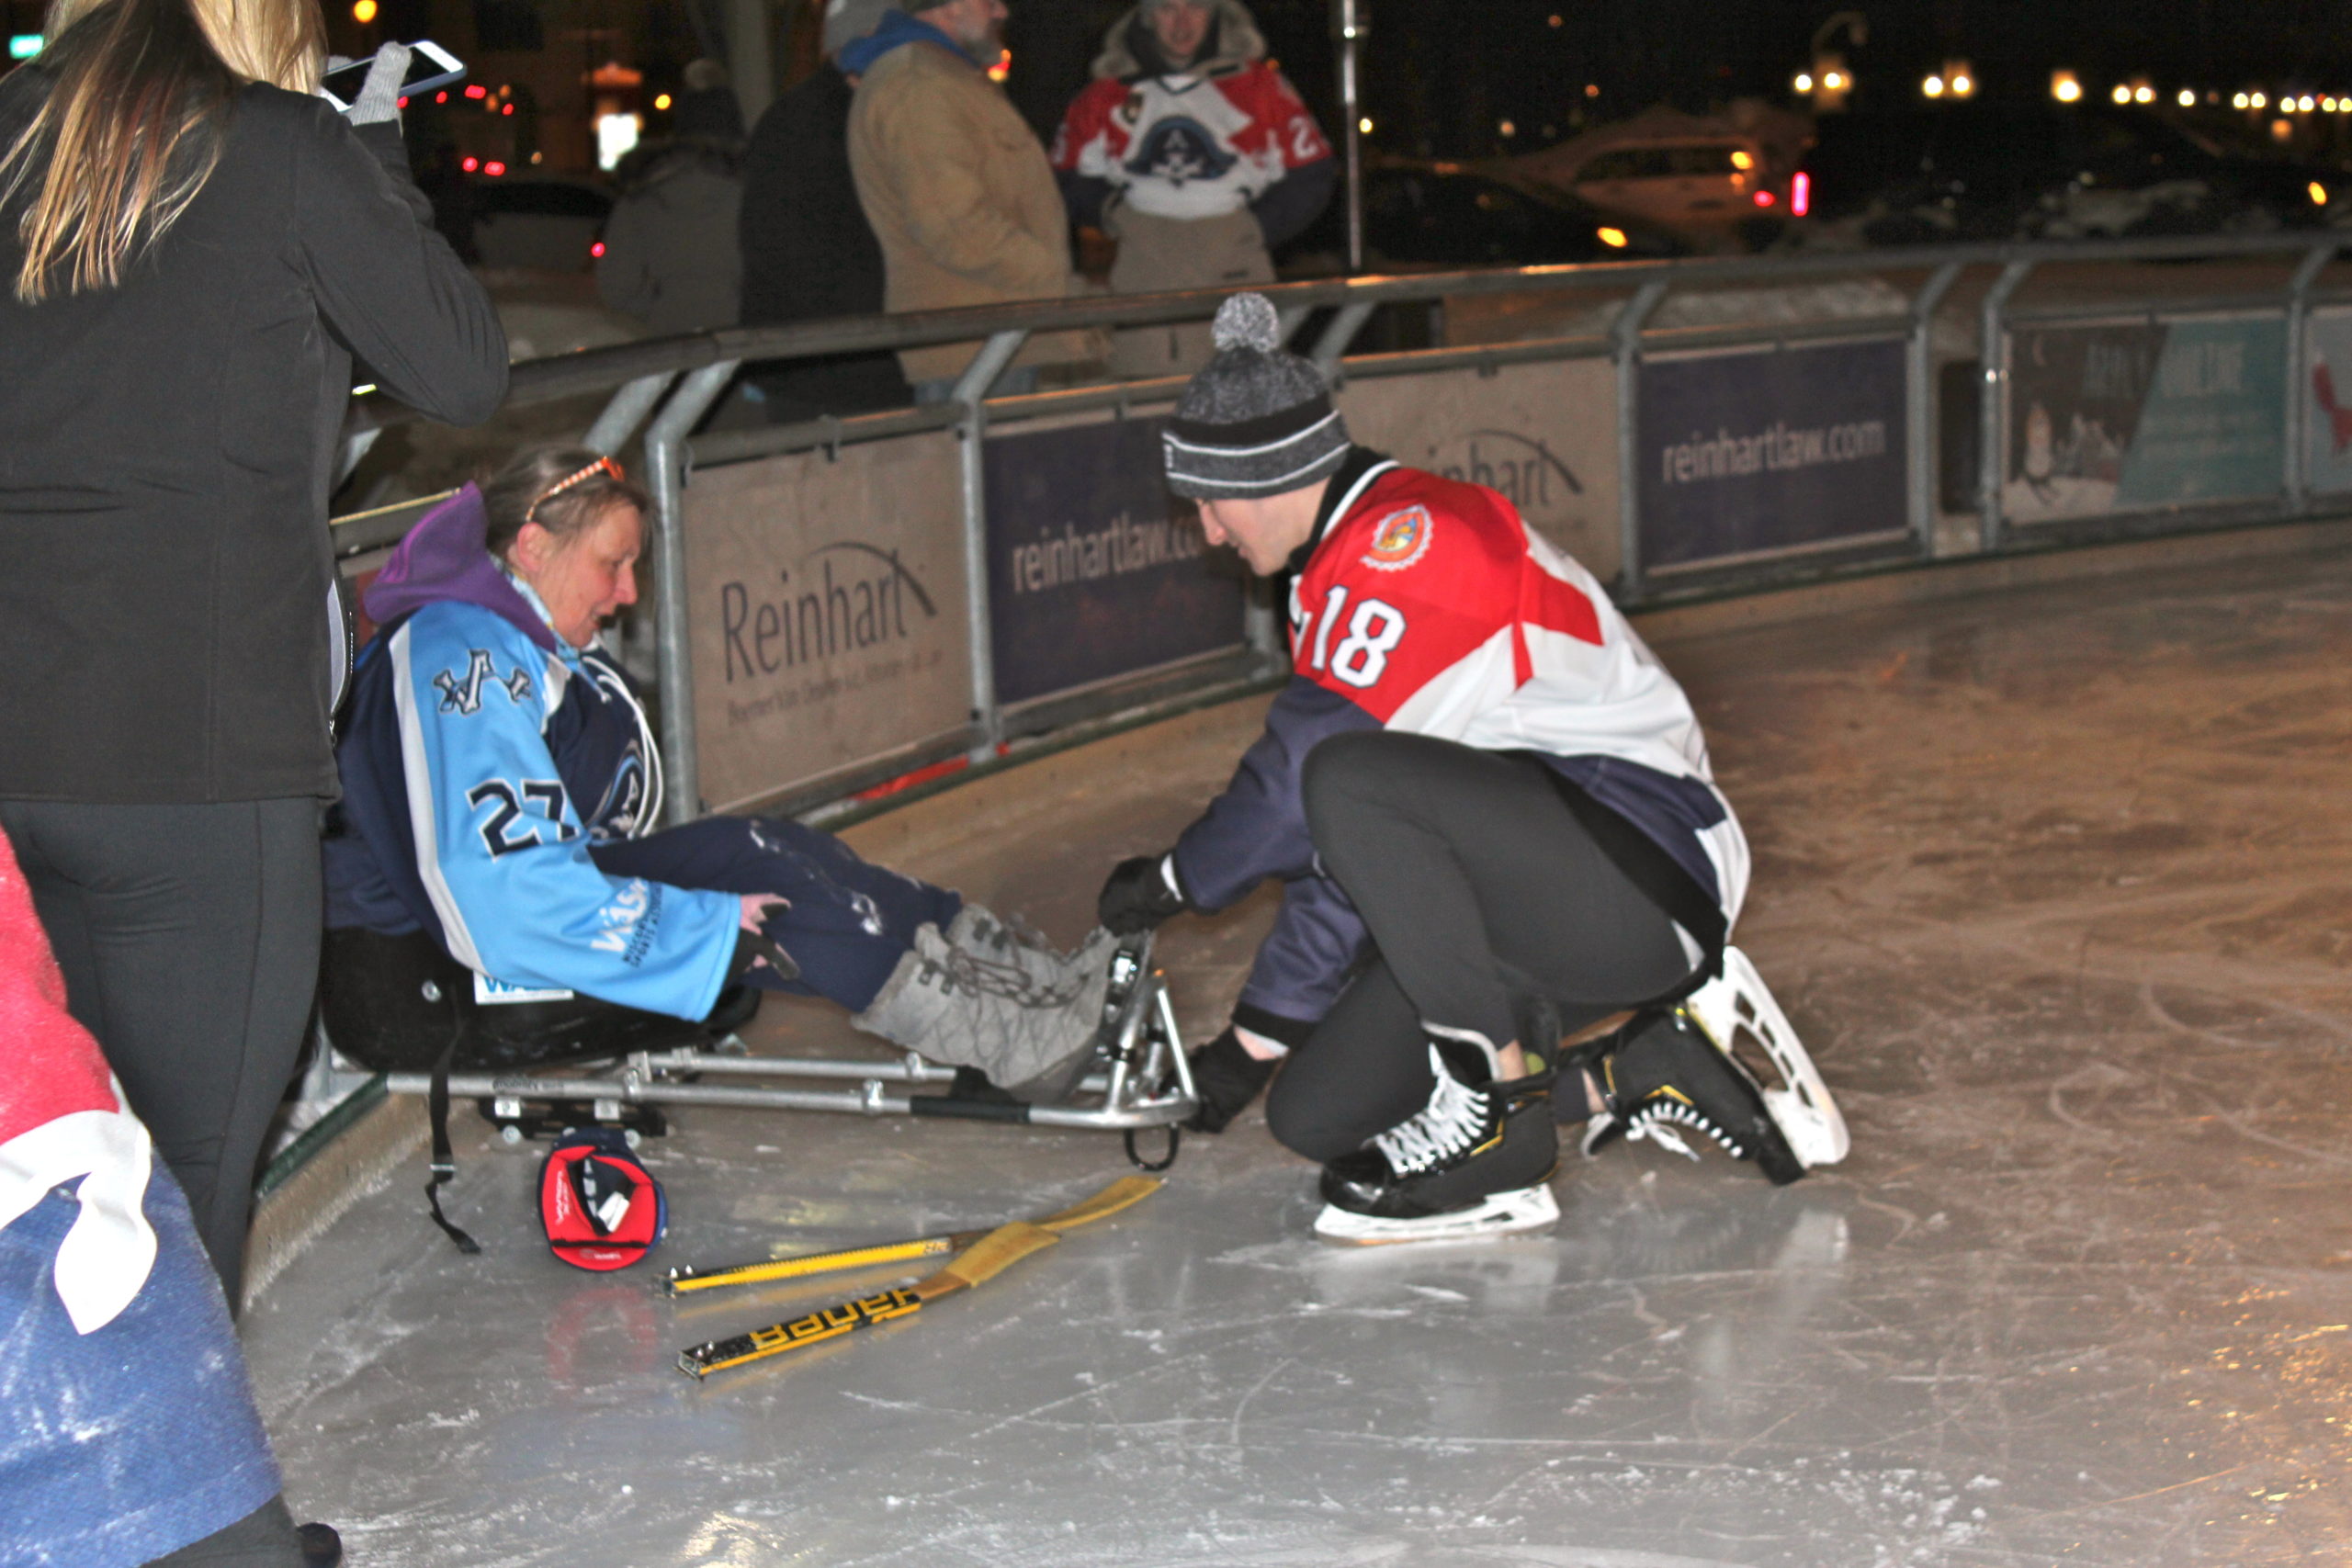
left=1101, top=294, right=1809, bottom=1241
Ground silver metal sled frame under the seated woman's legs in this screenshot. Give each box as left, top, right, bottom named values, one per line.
left=383, top=936, right=1200, bottom=1142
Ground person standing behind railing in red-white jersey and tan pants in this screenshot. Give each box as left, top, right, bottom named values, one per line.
left=1054, top=0, right=1339, bottom=376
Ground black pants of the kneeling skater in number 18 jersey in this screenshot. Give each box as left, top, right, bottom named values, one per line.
left=1265, top=731, right=1691, bottom=1161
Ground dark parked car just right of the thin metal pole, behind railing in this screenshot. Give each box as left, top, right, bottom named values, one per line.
left=1364, top=160, right=1687, bottom=270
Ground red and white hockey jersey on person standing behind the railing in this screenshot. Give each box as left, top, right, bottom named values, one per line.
left=1054, top=62, right=1331, bottom=219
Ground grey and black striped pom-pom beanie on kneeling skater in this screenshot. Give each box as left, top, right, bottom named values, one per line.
left=1159, top=294, right=1348, bottom=501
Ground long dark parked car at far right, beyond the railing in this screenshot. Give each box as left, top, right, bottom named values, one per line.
left=1790, top=104, right=2343, bottom=244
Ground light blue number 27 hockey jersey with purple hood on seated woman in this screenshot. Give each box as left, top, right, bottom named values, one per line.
left=327, top=484, right=736, bottom=1018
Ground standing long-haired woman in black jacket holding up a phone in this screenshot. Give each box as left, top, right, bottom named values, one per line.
left=0, top=0, right=505, bottom=1303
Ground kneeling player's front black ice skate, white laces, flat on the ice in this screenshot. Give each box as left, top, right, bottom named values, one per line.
left=1315, top=1042, right=1559, bottom=1246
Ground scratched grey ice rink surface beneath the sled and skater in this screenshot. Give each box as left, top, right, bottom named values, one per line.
left=244, top=536, right=2352, bottom=1568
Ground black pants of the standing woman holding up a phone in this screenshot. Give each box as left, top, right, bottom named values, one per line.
left=0, top=797, right=322, bottom=1312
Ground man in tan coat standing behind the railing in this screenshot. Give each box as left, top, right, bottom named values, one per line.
left=840, top=0, right=1099, bottom=402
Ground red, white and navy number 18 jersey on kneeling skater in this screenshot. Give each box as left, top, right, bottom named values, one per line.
left=1173, top=451, right=1747, bottom=1032
